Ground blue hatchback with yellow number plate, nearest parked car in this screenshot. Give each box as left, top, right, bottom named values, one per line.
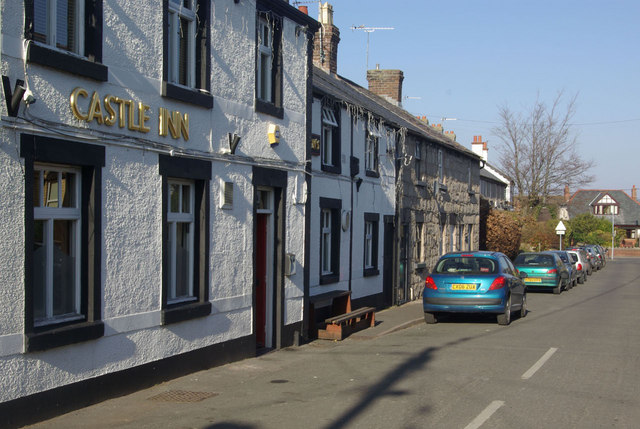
left=422, top=251, right=527, bottom=325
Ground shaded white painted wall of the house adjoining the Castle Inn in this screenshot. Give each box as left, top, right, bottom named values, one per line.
left=309, top=98, right=395, bottom=299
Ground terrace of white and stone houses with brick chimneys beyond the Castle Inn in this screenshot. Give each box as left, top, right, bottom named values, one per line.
left=308, top=3, right=480, bottom=316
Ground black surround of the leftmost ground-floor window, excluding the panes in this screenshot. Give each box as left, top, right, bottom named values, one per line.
left=20, top=134, right=105, bottom=352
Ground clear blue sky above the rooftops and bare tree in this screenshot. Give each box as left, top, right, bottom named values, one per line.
left=300, top=0, right=640, bottom=192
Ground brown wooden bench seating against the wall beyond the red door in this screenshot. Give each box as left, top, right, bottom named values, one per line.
left=309, top=290, right=375, bottom=340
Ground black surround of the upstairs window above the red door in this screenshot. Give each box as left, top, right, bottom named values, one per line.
left=254, top=5, right=284, bottom=119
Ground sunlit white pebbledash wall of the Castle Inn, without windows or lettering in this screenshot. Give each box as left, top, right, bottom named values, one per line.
left=0, top=0, right=307, bottom=402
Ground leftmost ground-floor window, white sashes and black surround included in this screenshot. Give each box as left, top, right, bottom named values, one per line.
left=20, top=134, right=105, bottom=352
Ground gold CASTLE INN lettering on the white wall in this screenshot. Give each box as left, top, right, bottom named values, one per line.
left=69, top=87, right=189, bottom=140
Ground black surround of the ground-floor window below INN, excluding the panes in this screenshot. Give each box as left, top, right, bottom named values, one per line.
left=158, top=154, right=212, bottom=325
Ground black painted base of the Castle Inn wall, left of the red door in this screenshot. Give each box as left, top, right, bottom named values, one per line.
left=0, top=334, right=255, bottom=428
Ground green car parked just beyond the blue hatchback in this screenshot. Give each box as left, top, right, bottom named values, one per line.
left=513, top=252, right=569, bottom=294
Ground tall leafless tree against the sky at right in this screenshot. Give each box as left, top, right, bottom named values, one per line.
left=493, top=92, right=594, bottom=206
